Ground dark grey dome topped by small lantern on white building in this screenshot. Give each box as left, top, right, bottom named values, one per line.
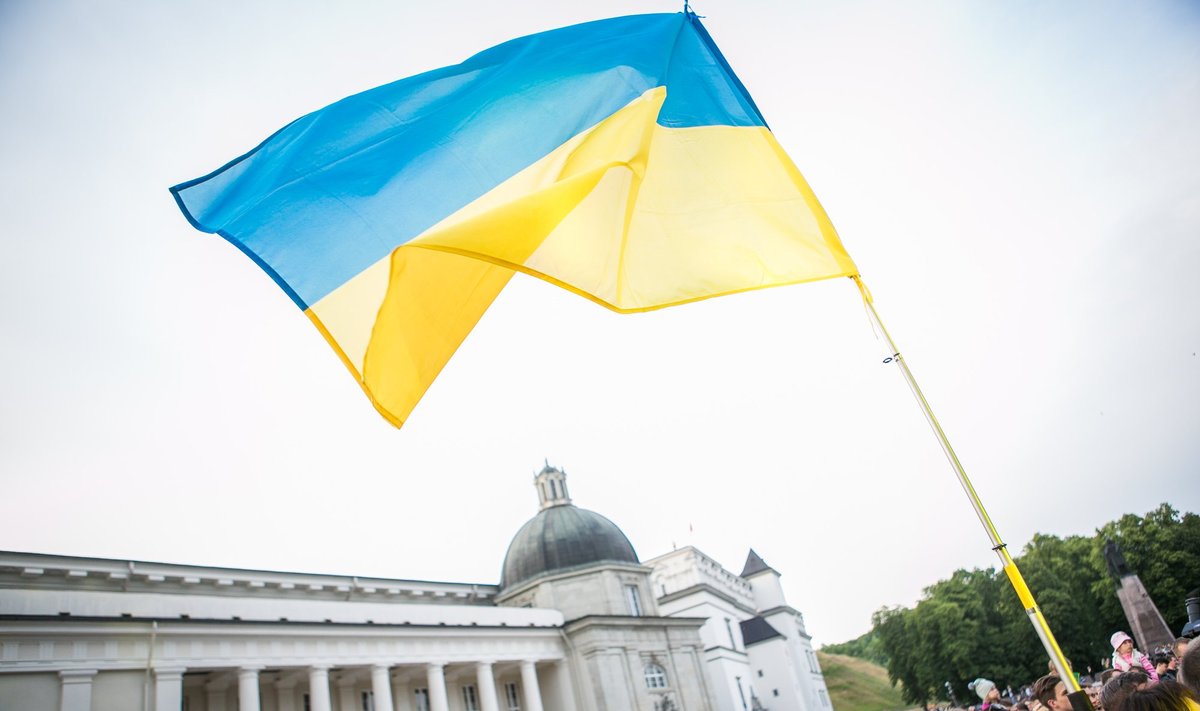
left=500, top=464, right=638, bottom=590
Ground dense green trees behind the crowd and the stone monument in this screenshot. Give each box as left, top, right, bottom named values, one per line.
left=854, top=503, right=1200, bottom=704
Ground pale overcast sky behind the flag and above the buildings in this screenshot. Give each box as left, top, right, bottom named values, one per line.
left=0, top=0, right=1200, bottom=643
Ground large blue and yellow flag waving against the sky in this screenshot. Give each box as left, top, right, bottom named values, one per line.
left=172, top=12, right=857, bottom=426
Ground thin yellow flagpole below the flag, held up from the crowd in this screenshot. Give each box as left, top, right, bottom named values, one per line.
left=851, top=276, right=1080, bottom=693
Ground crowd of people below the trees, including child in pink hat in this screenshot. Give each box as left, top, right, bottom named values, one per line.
left=950, top=632, right=1200, bottom=711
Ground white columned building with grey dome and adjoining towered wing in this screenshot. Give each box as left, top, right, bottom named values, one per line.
left=0, top=465, right=828, bottom=711
